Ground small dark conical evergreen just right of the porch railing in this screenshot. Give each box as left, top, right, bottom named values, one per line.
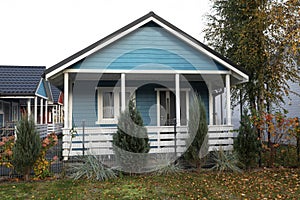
left=233, top=110, right=261, bottom=169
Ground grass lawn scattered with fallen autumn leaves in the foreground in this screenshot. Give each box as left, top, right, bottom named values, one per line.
left=0, top=168, right=300, bottom=199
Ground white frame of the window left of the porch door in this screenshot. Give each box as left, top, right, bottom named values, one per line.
left=96, top=87, right=136, bottom=124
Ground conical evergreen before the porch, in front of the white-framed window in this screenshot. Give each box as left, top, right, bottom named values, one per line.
left=112, top=100, right=150, bottom=173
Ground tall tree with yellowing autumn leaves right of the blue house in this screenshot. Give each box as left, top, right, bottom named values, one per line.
left=205, top=0, right=300, bottom=165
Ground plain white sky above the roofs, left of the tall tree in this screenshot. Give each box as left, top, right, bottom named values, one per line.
left=0, top=0, right=209, bottom=68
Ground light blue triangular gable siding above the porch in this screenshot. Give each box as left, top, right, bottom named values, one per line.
left=70, top=26, right=226, bottom=70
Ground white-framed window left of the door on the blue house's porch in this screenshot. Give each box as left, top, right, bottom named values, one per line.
left=96, top=87, right=135, bottom=124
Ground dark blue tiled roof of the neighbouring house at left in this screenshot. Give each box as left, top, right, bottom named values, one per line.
left=0, top=66, right=45, bottom=97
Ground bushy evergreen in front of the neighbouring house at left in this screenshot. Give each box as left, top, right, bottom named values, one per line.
left=12, top=115, right=41, bottom=181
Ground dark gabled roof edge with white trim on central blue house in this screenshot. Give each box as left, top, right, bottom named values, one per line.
left=45, top=12, right=248, bottom=82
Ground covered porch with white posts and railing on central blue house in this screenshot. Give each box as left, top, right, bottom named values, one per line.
left=60, top=70, right=237, bottom=159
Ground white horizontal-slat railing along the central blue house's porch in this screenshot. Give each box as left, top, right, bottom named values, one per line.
left=63, top=126, right=234, bottom=159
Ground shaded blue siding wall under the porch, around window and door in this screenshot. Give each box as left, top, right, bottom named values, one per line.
left=73, top=81, right=208, bottom=127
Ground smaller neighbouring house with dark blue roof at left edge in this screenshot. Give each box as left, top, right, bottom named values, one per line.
left=0, top=66, right=63, bottom=136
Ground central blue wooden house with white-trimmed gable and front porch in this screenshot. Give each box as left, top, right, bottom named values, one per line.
left=45, top=12, right=248, bottom=158
